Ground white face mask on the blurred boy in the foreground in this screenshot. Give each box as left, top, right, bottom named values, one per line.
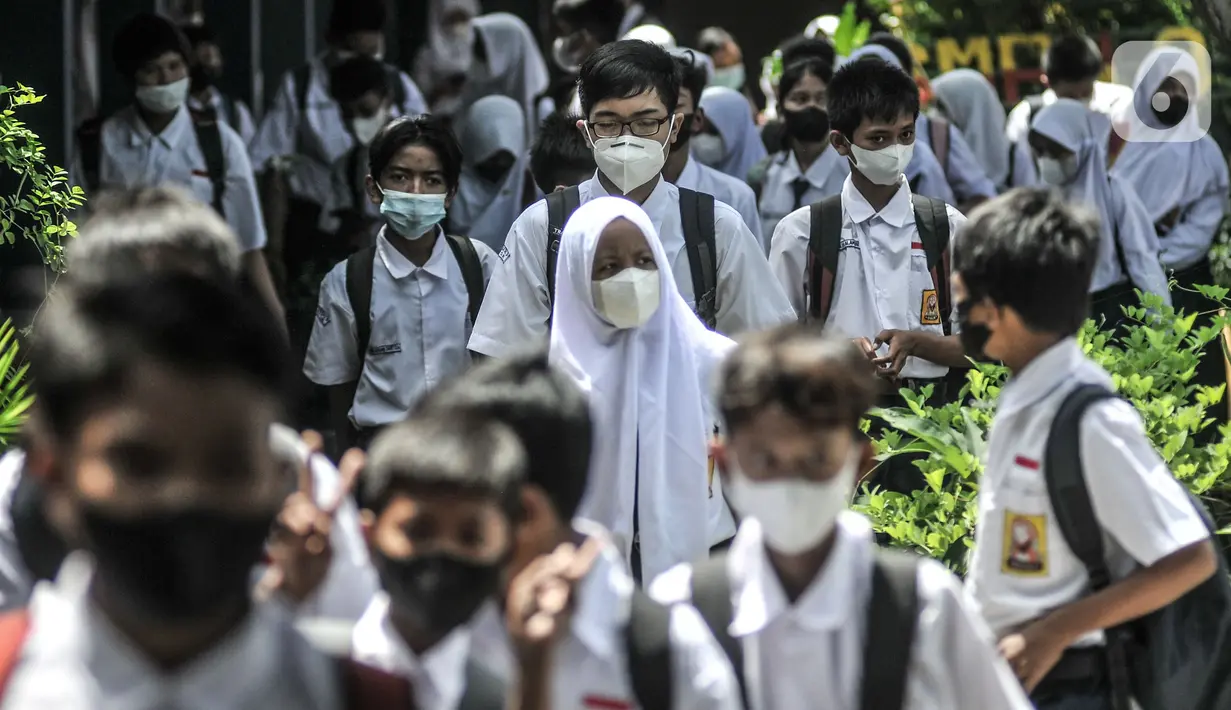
left=726, top=455, right=859, bottom=555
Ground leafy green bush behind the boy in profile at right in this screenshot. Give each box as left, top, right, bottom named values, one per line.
left=856, top=287, right=1231, bottom=573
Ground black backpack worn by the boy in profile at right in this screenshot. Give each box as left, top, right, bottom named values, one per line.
left=1043, top=385, right=1231, bottom=710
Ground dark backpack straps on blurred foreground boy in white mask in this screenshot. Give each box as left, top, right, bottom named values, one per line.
left=692, top=548, right=920, bottom=710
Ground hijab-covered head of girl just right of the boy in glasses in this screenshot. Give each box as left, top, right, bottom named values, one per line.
left=692, top=86, right=767, bottom=180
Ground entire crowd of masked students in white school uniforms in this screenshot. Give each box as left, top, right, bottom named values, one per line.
left=0, top=0, right=1231, bottom=710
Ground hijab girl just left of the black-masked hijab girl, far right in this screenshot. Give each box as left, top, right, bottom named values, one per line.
left=1028, top=98, right=1171, bottom=326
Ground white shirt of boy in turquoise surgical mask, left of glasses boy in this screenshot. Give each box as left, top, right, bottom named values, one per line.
left=304, top=228, right=496, bottom=428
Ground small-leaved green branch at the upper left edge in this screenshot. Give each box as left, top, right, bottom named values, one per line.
left=0, top=84, right=85, bottom=272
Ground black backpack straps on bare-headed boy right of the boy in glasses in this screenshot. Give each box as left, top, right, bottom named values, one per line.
left=804, top=194, right=953, bottom=335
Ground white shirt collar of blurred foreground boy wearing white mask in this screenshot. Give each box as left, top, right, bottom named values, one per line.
left=729, top=511, right=872, bottom=637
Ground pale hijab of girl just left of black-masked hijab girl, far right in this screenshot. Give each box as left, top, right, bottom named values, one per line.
left=1030, top=98, right=1115, bottom=245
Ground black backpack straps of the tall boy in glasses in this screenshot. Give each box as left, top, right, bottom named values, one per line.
left=547, top=186, right=718, bottom=330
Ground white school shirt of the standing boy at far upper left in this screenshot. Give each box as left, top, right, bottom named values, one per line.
left=73, top=106, right=266, bottom=252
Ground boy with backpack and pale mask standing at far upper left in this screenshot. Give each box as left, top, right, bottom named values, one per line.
left=73, top=14, right=282, bottom=319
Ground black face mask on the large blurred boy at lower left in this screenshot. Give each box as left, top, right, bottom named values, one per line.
left=81, top=506, right=276, bottom=623
